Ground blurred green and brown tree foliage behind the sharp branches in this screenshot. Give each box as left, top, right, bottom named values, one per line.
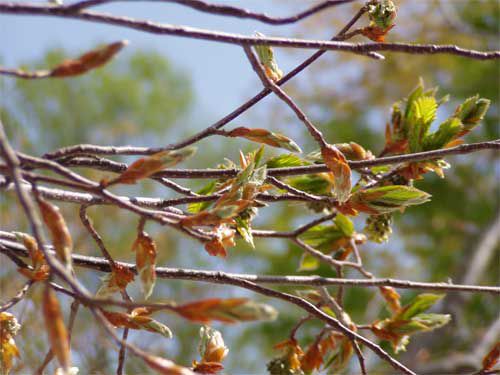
left=0, top=0, right=500, bottom=374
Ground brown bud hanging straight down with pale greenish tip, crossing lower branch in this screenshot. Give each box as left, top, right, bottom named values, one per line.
left=132, top=232, right=157, bottom=299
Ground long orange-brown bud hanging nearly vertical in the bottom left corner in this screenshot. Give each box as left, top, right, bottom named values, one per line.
left=42, top=284, right=71, bottom=371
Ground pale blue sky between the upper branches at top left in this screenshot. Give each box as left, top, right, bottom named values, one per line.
left=0, top=0, right=332, bottom=121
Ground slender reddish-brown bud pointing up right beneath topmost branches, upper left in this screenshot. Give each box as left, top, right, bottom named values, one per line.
left=49, top=40, right=128, bottom=77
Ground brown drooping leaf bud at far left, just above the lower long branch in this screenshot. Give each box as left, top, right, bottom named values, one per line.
left=38, top=199, right=73, bottom=269
